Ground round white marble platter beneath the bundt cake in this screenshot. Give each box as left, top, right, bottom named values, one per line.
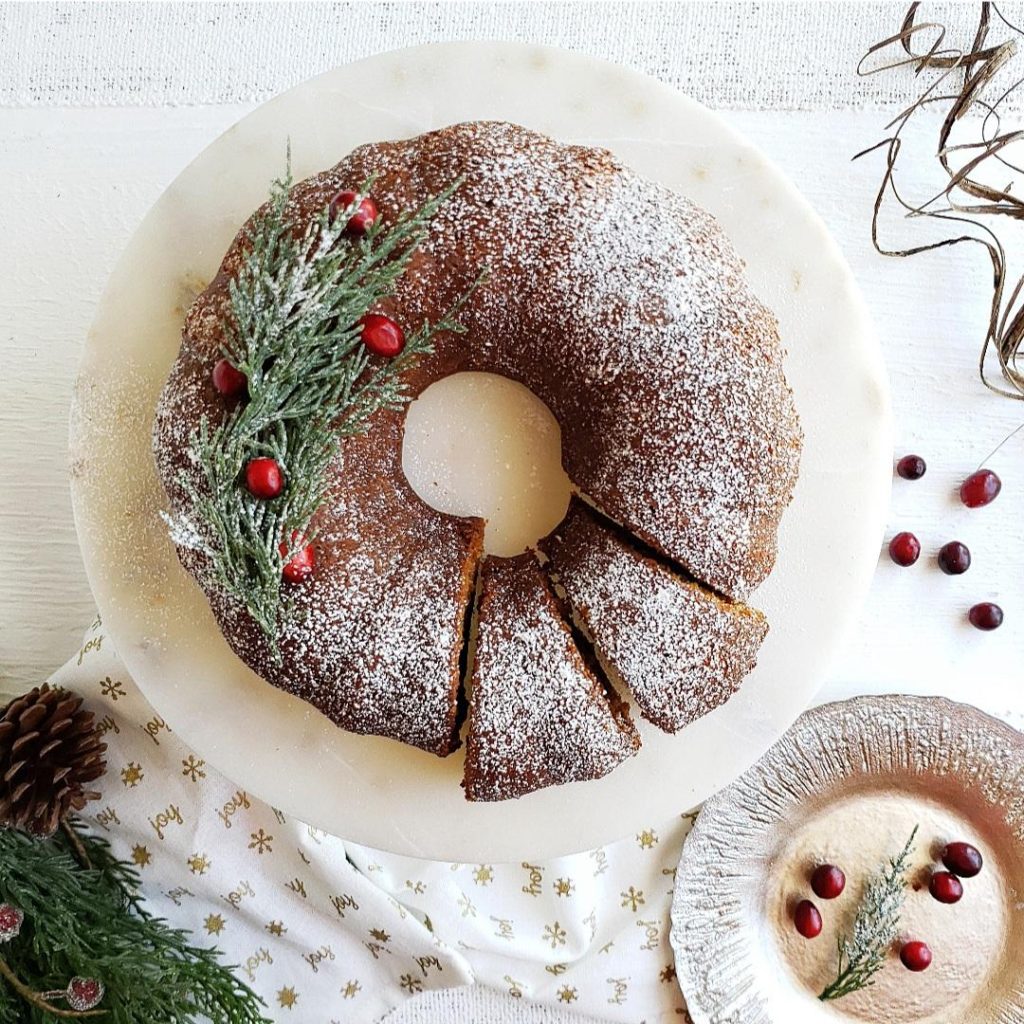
left=71, top=43, right=891, bottom=861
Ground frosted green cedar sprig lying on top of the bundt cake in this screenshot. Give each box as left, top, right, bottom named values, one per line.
left=166, top=167, right=475, bottom=657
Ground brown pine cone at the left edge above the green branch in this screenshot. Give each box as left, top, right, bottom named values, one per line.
left=0, top=683, right=106, bottom=836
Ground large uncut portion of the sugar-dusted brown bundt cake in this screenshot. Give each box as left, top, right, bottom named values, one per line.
left=154, top=122, right=801, bottom=770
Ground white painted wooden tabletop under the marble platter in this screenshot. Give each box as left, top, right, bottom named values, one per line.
left=0, top=4, right=1024, bottom=1024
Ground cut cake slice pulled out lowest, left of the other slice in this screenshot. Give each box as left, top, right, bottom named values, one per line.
left=463, top=554, right=640, bottom=801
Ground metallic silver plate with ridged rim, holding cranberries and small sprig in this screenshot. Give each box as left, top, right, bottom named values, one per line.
left=672, top=696, right=1024, bottom=1024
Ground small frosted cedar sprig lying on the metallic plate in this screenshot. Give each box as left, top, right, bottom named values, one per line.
left=818, top=825, right=918, bottom=1001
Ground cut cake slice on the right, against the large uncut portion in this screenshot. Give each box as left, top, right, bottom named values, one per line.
left=541, top=498, right=768, bottom=732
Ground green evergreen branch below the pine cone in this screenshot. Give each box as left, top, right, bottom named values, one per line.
left=0, top=824, right=269, bottom=1024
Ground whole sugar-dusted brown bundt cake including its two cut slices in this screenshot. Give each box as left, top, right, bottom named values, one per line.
left=154, top=114, right=801, bottom=799
